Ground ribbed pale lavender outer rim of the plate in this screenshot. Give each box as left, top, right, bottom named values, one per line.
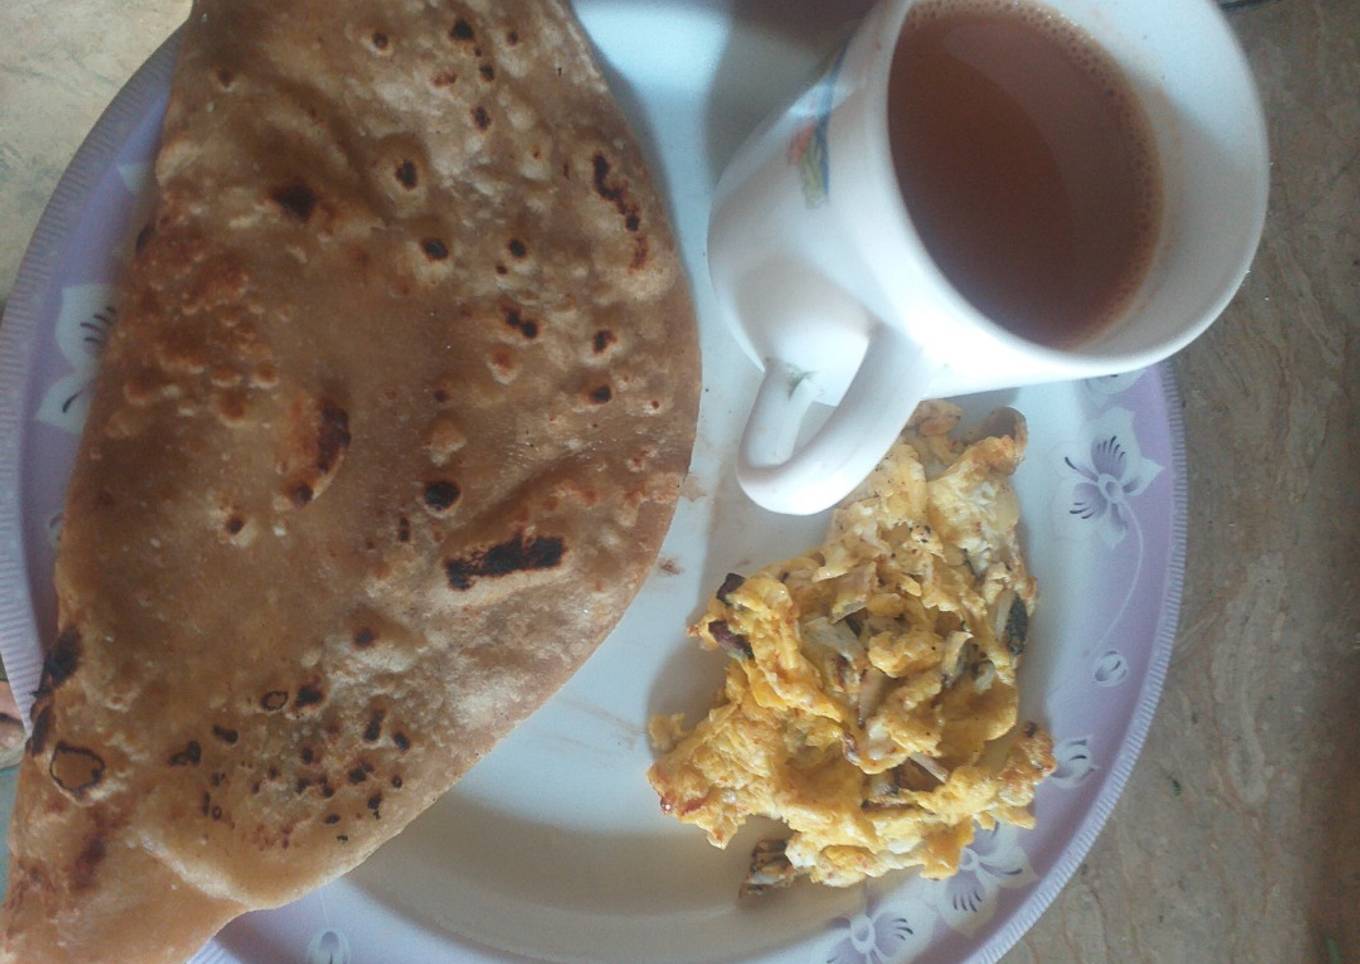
left=0, top=16, right=1189, bottom=964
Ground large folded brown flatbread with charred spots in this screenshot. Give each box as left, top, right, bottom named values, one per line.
left=0, top=0, right=699, bottom=961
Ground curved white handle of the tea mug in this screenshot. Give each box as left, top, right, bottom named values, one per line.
left=737, top=322, right=929, bottom=515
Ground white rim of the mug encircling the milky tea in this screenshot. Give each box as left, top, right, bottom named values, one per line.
left=864, top=0, right=1270, bottom=378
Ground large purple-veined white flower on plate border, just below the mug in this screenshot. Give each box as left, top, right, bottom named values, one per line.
left=1062, top=408, right=1161, bottom=548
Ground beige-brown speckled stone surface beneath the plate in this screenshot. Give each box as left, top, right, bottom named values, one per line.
left=0, top=0, right=1360, bottom=963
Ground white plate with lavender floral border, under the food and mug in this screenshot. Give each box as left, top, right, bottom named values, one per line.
left=0, top=0, right=1186, bottom=964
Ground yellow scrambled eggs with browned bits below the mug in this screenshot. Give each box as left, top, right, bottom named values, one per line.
left=647, top=402, right=1054, bottom=893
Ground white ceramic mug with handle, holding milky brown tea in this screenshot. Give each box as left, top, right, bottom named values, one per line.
left=709, top=0, right=1269, bottom=514
